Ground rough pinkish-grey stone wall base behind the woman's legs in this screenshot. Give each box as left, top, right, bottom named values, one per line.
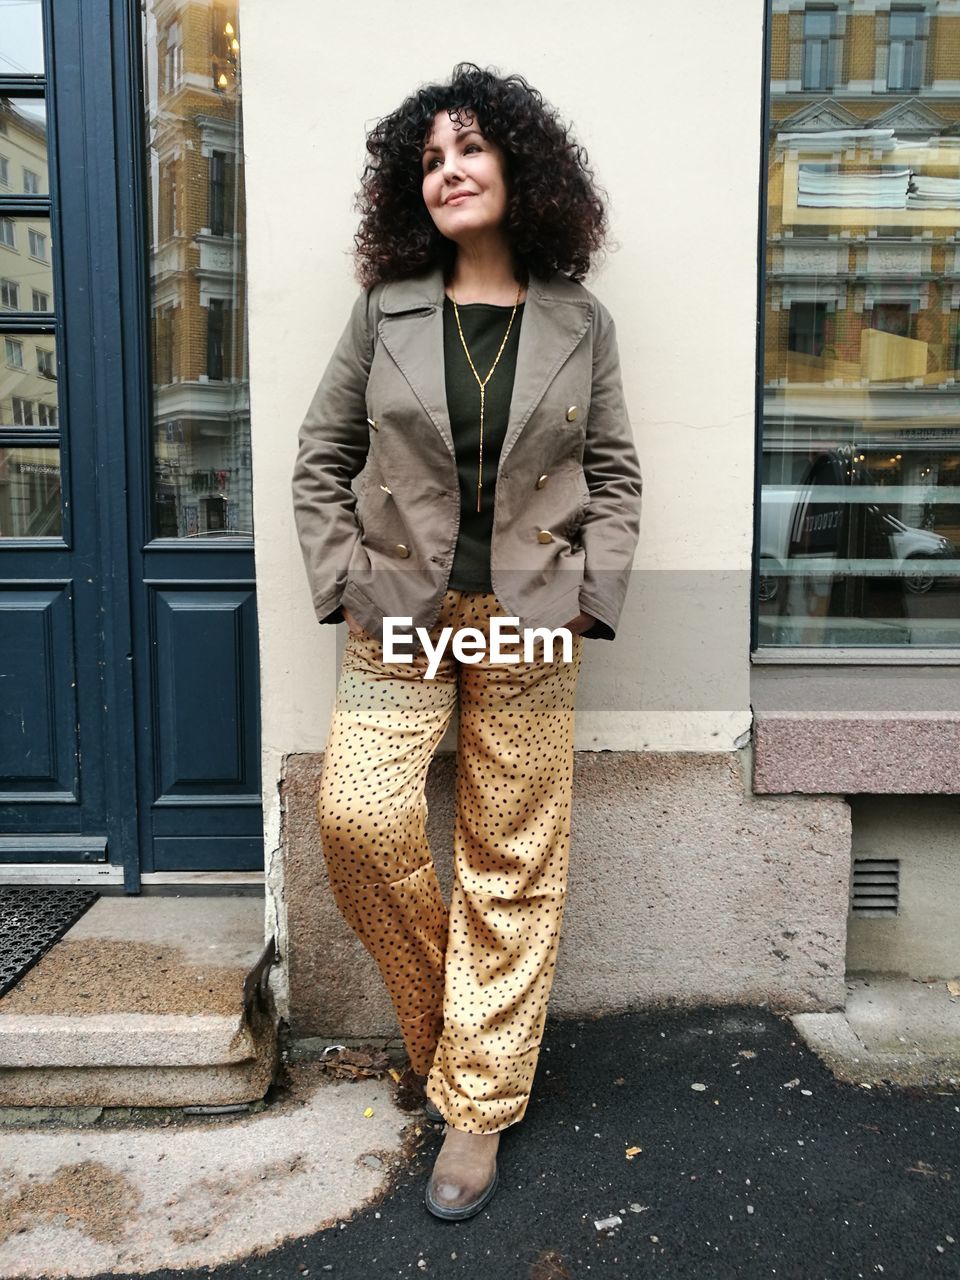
left=282, top=751, right=851, bottom=1037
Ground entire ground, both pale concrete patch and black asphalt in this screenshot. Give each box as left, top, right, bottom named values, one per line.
left=0, top=1007, right=960, bottom=1280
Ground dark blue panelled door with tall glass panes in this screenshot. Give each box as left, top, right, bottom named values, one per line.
left=0, top=0, right=262, bottom=891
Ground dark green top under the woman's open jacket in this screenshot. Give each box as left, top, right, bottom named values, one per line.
left=443, top=298, right=524, bottom=591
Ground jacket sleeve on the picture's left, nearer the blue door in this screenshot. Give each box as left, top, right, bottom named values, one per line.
left=293, top=289, right=376, bottom=622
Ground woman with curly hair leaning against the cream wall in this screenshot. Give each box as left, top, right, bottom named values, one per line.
left=293, top=63, right=641, bottom=1219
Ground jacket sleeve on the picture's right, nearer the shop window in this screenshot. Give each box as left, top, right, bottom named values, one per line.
left=580, top=300, right=643, bottom=640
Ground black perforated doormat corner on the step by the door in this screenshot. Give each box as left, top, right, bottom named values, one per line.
left=0, top=884, right=100, bottom=996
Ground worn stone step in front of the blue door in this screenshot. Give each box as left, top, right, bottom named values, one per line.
left=0, top=896, right=276, bottom=1106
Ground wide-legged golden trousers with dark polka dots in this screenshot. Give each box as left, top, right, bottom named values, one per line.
left=319, top=591, right=582, bottom=1133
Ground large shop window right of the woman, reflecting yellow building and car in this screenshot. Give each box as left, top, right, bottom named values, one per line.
left=758, top=4, right=960, bottom=648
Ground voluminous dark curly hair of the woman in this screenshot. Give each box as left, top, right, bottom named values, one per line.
left=355, top=63, right=607, bottom=285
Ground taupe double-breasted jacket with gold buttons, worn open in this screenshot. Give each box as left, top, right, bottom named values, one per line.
left=293, top=263, right=641, bottom=639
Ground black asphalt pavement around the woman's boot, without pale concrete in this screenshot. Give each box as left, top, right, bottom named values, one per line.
left=88, top=1007, right=960, bottom=1280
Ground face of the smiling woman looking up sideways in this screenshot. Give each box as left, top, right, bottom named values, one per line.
left=422, top=111, right=507, bottom=244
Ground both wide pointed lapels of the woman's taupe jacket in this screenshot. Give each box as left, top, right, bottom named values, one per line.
left=379, top=268, right=590, bottom=462
